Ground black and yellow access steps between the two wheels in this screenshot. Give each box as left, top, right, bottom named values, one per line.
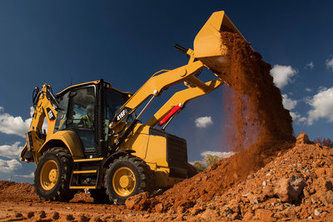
left=69, top=158, right=104, bottom=189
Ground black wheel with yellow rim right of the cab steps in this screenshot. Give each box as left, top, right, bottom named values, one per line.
left=104, top=155, right=153, bottom=204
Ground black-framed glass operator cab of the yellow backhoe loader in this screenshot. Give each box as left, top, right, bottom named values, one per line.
left=54, top=80, right=132, bottom=158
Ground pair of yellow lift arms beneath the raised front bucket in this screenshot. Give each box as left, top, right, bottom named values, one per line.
left=110, top=49, right=224, bottom=146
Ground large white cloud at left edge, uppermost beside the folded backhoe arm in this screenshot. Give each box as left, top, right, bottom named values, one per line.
left=0, top=107, right=31, bottom=137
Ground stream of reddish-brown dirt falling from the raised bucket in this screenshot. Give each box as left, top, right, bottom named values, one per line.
left=221, top=32, right=294, bottom=151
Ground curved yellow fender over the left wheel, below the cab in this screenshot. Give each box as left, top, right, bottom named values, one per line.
left=36, top=130, right=84, bottom=159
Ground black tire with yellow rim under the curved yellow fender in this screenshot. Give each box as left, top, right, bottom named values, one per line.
left=34, top=147, right=75, bottom=202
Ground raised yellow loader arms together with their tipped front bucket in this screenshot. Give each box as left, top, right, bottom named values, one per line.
left=110, top=11, right=244, bottom=135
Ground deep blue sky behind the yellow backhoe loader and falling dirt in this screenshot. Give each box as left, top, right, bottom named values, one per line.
left=0, top=0, right=333, bottom=182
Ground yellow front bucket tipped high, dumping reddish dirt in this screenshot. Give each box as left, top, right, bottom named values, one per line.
left=193, top=11, right=245, bottom=74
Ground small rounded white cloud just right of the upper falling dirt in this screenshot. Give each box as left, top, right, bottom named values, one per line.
left=271, top=65, right=297, bottom=89
